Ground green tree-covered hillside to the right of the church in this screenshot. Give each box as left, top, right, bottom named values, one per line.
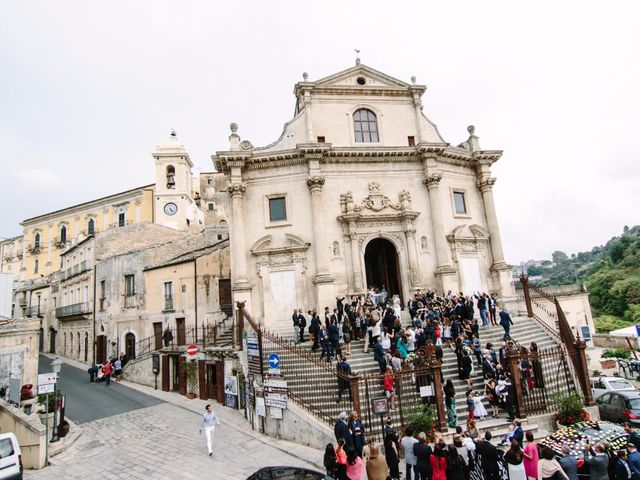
left=527, top=225, right=640, bottom=332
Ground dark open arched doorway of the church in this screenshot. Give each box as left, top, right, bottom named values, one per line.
left=364, top=238, right=404, bottom=305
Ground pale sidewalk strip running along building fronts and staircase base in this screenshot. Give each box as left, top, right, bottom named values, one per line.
left=45, top=354, right=324, bottom=471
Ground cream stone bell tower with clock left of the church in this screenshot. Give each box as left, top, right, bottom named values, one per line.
left=152, top=130, right=203, bottom=230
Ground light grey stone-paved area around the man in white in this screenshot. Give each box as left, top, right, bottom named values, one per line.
left=24, top=402, right=322, bottom=480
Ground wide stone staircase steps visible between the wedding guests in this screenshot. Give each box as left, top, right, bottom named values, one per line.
left=263, top=311, right=556, bottom=437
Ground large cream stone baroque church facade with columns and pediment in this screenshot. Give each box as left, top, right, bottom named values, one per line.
left=212, top=60, right=514, bottom=329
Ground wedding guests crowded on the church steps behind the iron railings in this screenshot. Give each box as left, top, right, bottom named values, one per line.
left=292, top=286, right=544, bottom=427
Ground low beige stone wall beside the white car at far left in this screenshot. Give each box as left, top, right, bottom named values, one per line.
left=0, top=400, right=47, bottom=468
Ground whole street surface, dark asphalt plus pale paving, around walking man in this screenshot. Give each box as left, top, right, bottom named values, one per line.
left=29, top=357, right=322, bottom=480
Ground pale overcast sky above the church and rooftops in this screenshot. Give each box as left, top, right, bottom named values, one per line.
left=0, top=0, right=640, bottom=264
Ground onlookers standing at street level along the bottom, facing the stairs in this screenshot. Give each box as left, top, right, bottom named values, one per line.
left=324, top=412, right=640, bottom=480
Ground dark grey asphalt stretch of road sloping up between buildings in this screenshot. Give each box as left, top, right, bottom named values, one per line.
left=38, top=355, right=162, bottom=423
